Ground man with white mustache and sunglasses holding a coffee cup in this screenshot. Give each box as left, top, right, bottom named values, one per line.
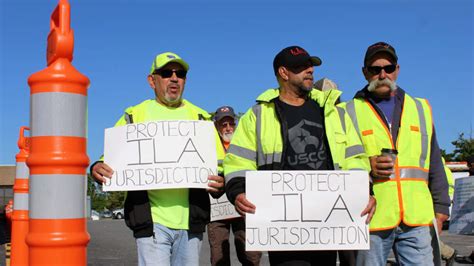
left=343, top=42, right=450, bottom=265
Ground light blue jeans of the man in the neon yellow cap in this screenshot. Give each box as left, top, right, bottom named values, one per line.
left=136, top=223, right=202, bottom=266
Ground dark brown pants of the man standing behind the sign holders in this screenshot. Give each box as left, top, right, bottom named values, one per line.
left=207, top=217, right=262, bottom=266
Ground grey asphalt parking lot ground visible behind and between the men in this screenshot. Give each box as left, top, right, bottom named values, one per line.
left=0, top=219, right=474, bottom=266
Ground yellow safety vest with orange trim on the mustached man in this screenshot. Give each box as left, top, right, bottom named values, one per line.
left=345, top=94, right=434, bottom=231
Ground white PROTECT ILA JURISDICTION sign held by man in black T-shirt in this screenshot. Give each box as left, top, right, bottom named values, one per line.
left=246, top=171, right=370, bottom=251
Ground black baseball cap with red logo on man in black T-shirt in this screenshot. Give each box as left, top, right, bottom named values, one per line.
left=273, top=46, right=322, bottom=76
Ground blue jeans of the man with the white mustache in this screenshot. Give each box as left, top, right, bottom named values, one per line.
left=356, top=224, right=433, bottom=266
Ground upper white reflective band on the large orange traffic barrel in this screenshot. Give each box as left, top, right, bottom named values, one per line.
left=30, top=92, right=87, bottom=138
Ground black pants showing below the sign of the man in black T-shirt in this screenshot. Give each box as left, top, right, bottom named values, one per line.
left=268, top=251, right=337, bottom=266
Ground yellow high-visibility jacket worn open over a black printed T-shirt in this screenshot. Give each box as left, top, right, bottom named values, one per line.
left=224, top=89, right=370, bottom=185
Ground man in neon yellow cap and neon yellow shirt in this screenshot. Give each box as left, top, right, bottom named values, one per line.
left=90, top=52, right=224, bottom=266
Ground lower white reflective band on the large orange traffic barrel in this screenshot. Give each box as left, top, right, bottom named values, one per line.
left=29, top=174, right=87, bottom=219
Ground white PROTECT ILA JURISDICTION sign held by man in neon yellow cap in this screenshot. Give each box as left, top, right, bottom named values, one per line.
left=103, top=121, right=217, bottom=191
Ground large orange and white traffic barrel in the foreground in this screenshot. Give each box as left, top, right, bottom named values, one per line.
left=26, top=0, right=90, bottom=265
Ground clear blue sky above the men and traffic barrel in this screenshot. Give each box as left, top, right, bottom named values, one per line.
left=0, top=0, right=474, bottom=164
